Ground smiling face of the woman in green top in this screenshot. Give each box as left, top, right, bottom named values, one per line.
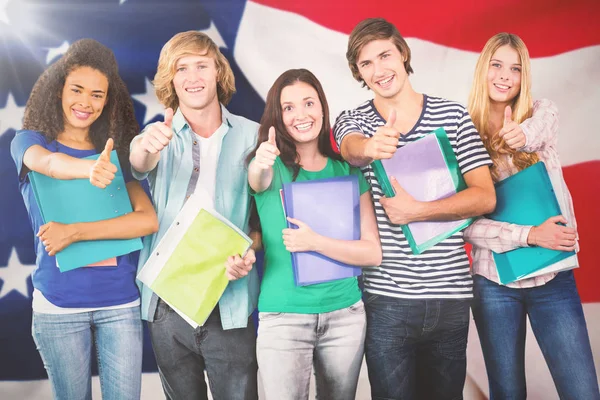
left=280, top=82, right=323, bottom=143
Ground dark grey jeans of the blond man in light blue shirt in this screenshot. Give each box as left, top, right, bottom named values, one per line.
left=148, top=300, right=258, bottom=400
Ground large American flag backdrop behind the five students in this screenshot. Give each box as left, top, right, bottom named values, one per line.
left=0, top=0, right=600, bottom=400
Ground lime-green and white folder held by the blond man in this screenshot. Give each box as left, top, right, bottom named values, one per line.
left=138, top=202, right=252, bottom=325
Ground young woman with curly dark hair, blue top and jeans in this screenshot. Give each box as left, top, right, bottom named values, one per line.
left=11, top=39, right=158, bottom=399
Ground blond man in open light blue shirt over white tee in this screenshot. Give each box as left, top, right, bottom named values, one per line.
left=130, top=31, right=258, bottom=400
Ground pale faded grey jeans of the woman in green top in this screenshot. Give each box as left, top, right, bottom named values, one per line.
left=256, top=301, right=366, bottom=400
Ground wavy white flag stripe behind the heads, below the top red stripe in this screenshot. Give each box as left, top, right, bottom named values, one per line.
left=234, top=2, right=600, bottom=165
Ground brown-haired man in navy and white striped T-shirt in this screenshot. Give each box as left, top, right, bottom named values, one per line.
left=334, top=18, right=496, bottom=400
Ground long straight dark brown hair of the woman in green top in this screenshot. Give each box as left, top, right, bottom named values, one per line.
left=246, top=69, right=342, bottom=179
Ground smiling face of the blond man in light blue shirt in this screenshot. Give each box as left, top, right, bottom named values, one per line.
left=173, top=55, right=219, bottom=114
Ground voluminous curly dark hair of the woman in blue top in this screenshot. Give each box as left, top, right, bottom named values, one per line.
left=23, top=39, right=139, bottom=164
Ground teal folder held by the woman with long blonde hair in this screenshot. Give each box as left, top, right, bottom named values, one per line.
left=487, top=161, right=575, bottom=284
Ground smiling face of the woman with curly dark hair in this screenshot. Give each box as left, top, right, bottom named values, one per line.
left=61, top=67, right=108, bottom=132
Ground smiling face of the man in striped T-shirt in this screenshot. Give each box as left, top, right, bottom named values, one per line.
left=356, top=39, right=408, bottom=99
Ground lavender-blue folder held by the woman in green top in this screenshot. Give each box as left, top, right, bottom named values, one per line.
left=283, top=175, right=361, bottom=286
